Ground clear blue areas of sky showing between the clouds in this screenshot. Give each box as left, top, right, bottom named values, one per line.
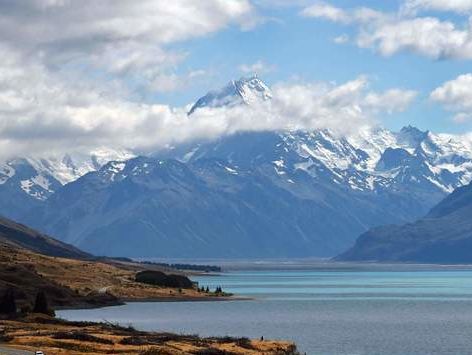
left=154, top=0, right=472, bottom=133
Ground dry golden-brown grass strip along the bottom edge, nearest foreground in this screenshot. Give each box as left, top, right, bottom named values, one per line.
left=0, top=316, right=296, bottom=355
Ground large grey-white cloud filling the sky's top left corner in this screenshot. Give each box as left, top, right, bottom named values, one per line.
left=0, top=0, right=257, bottom=95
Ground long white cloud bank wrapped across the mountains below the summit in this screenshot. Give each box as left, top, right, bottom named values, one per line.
left=0, top=53, right=416, bottom=160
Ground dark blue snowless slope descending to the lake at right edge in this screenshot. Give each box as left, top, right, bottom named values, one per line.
left=336, top=185, right=472, bottom=263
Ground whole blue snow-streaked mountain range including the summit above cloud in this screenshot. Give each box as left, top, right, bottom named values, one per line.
left=0, top=77, right=472, bottom=257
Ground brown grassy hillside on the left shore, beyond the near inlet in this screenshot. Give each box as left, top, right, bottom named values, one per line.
left=0, top=243, right=230, bottom=307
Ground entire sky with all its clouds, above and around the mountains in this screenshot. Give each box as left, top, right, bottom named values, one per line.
left=0, top=0, right=472, bottom=154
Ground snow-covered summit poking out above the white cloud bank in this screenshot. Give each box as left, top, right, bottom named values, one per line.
left=188, top=75, right=272, bottom=115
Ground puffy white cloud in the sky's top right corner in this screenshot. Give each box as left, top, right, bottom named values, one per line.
left=302, top=0, right=472, bottom=60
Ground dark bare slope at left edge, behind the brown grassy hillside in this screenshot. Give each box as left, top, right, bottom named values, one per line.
left=0, top=218, right=90, bottom=258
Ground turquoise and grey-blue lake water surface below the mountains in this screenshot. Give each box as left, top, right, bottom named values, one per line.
left=58, top=264, right=472, bottom=355
